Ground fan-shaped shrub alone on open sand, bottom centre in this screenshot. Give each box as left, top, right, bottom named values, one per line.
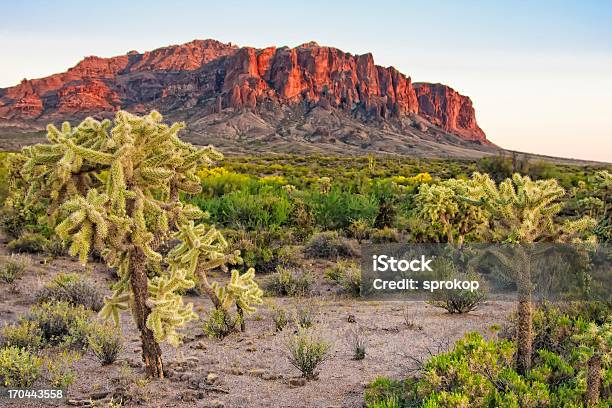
left=287, top=328, right=330, bottom=379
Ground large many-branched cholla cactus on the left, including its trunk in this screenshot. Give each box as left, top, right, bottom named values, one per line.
left=17, top=111, right=237, bottom=377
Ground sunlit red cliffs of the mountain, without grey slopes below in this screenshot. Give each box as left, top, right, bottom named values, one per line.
left=0, top=40, right=486, bottom=142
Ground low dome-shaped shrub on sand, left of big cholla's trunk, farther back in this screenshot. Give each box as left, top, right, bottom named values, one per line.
left=36, top=273, right=104, bottom=312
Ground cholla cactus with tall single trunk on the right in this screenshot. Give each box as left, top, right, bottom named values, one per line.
left=464, top=173, right=595, bottom=374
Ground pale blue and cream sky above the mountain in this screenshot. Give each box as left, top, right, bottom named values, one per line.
left=0, top=0, right=612, bottom=162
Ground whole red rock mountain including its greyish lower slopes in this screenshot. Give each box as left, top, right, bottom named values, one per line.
left=0, top=40, right=489, bottom=155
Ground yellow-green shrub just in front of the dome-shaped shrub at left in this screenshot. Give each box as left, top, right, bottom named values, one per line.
left=22, top=302, right=91, bottom=347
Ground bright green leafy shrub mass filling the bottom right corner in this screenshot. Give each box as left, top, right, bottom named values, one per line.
left=365, top=326, right=612, bottom=408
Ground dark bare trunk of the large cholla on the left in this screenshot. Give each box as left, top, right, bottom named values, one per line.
left=130, top=250, right=164, bottom=378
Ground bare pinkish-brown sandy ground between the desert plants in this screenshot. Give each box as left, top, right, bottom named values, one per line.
left=0, top=242, right=512, bottom=407
